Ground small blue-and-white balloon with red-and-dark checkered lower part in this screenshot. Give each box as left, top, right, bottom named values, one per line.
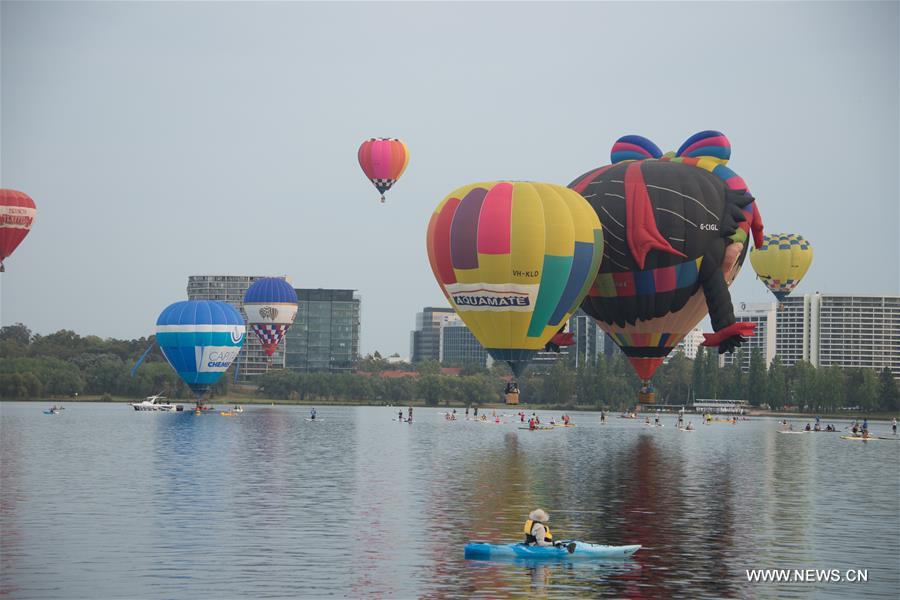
left=244, top=277, right=297, bottom=356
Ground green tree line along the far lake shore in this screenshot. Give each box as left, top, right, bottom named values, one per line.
left=0, top=323, right=900, bottom=415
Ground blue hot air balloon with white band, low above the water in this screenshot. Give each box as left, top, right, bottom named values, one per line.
left=156, top=300, right=245, bottom=408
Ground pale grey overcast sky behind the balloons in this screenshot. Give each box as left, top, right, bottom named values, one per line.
left=0, top=1, right=900, bottom=356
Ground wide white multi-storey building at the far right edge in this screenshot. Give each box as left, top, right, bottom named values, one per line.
left=776, top=293, right=900, bottom=378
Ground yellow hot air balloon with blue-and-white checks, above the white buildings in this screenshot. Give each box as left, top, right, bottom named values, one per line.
left=750, top=233, right=812, bottom=303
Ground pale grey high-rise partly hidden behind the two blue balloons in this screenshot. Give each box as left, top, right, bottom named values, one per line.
left=187, top=275, right=290, bottom=382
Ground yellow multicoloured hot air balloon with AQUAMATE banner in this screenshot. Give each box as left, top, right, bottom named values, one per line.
left=427, top=181, right=603, bottom=377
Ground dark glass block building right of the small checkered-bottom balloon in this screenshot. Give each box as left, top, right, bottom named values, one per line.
left=285, top=288, right=360, bottom=373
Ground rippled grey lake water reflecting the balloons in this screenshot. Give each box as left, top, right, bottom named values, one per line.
left=0, top=402, right=900, bottom=599
